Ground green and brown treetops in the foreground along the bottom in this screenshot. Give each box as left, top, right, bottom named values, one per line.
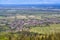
left=0, top=32, right=60, bottom=40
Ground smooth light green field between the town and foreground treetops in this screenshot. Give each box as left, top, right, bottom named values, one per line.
left=29, top=24, right=60, bottom=34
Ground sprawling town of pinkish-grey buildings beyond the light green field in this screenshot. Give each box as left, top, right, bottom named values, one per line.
left=9, top=18, right=60, bottom=30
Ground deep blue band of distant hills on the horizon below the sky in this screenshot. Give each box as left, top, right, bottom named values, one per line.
left=0, top=4, right=60, bottom=9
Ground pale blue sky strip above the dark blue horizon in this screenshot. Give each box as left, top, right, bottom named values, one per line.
left=0, top=0, right=60, bottom=4
